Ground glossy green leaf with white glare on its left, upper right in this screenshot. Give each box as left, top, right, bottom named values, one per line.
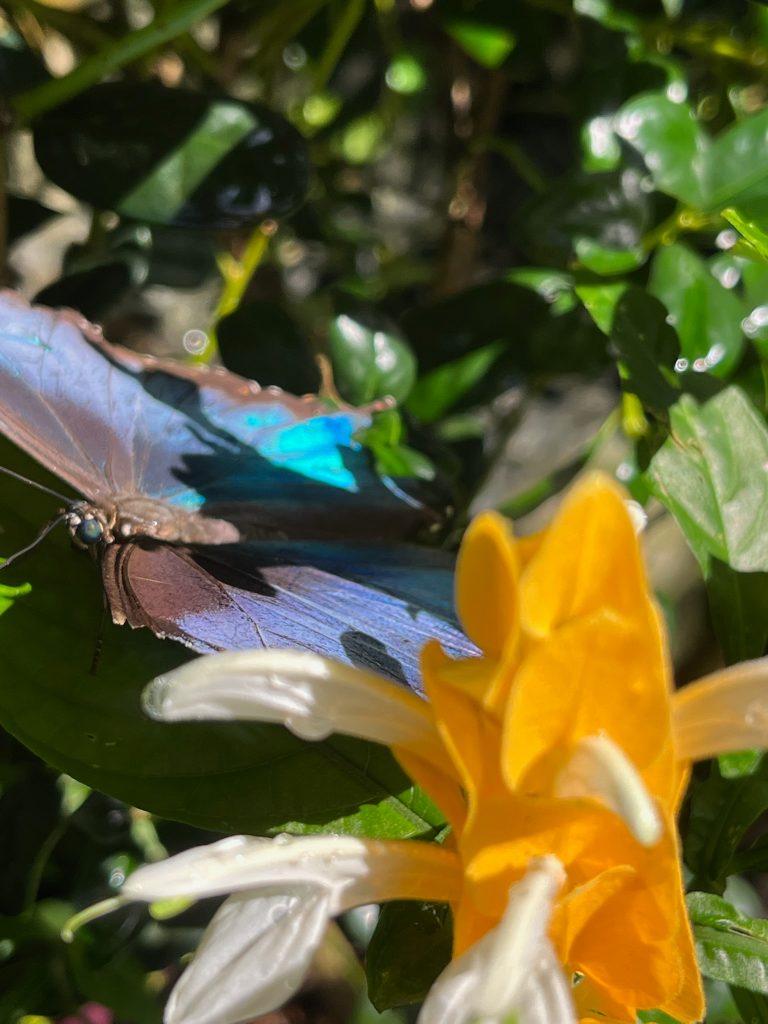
left=616, top=92, right=710, bottom=209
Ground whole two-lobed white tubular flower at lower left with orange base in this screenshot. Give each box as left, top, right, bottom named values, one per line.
left=122, top=836, right=461, bottom=1024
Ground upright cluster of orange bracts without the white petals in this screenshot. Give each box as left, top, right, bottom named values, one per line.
left=398, top=474, right=703, bottom=1022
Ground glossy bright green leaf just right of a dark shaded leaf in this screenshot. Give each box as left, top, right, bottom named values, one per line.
left=648, top=244, right=744, bottom=377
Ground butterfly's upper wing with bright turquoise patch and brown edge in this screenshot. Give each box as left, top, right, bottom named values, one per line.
left=0, top=292, right=430, bottom=537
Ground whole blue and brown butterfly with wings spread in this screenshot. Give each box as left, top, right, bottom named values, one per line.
left=0, top=292, right=473, bottom=688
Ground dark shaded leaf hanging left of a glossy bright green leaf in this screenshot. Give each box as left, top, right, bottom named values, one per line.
left=610, top=286, right=678, bottom=414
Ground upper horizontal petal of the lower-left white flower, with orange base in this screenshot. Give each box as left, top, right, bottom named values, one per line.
left=121, top=836, right=461, bottom=914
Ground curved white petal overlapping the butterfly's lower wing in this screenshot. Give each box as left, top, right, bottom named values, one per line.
left=143, top=649, right=445, bottom=765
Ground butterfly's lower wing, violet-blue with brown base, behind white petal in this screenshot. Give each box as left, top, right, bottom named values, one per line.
left=104, top=542, right=477, bottom=691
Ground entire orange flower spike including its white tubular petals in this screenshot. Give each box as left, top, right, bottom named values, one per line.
left=97, top=475, right=768, bottom=1024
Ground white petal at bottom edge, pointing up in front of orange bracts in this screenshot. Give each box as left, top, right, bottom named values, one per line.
left=419, top=857, right=575, bottom=1024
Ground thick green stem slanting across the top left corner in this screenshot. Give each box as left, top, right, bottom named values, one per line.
left=12, top=0, right=233, bottom=121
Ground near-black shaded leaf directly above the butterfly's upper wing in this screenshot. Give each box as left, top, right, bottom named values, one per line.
left=216, top=301, right=319, bottom=394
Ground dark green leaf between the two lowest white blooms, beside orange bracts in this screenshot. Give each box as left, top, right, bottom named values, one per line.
left=366, top=900, right=453, bottom=1012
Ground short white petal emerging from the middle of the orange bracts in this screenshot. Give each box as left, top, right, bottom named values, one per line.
left=554, top=736, right=664, bottom=846
